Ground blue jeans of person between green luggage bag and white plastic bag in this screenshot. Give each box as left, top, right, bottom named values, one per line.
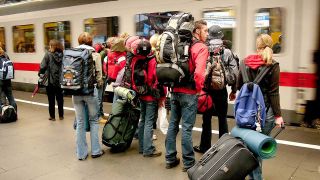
left=138, top=100, right=158, bottom=155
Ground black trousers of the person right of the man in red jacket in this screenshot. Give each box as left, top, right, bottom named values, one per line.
left=200, top=88, right=228, bottom=151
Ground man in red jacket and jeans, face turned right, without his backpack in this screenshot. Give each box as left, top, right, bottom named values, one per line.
left=165, top=20, right=208, bottom=172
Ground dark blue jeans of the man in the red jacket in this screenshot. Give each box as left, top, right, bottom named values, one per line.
left=165, top=93, right=198, bottom=169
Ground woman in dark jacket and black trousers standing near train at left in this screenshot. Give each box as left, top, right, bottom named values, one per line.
left=38, top=39, right=63, bottom=121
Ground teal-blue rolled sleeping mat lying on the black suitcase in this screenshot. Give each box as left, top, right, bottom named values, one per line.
left=231, top=126, right=277, bottom=159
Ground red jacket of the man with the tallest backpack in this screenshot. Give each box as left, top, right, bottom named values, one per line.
left=173, top=42, right=209, bottom=94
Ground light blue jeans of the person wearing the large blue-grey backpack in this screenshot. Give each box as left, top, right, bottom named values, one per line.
left=72, top=95, right=101, bottom=159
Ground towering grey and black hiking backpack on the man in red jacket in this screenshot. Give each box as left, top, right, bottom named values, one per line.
left=156, top=13, right=194, bottom=87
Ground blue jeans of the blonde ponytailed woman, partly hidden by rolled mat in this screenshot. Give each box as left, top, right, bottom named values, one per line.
left=249, top=107, right=275, bottom=180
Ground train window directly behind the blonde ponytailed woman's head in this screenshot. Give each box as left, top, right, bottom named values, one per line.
left=254, top=7, right=284, bottom=54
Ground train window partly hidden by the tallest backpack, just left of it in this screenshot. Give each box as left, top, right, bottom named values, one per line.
left=135, top=11, right=179, bottom=39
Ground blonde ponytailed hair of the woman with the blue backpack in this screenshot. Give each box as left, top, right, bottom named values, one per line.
left=256, top=34, right=273, bottom=65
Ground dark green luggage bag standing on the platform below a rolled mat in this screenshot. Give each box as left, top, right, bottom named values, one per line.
left=102, top=99, right=140, bottom=152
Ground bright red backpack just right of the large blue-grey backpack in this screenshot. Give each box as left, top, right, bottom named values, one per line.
left=106, top=52, right=126, bottom=82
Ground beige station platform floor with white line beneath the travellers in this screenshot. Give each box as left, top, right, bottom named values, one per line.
left=0, top=91, right=320, bottom=180
